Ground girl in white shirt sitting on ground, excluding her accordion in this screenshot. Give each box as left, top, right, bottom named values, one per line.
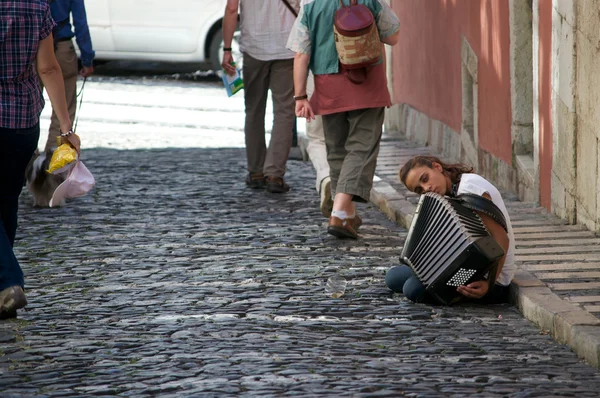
left=385, top=156, right=516, bottom=303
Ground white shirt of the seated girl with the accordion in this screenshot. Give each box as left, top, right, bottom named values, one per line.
left=457, top=173, right=517, bottom=286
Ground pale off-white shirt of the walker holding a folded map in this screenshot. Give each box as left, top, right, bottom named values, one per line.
left=240, top=0, right=300, bottom=61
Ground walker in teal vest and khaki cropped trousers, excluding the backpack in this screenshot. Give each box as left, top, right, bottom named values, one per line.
left=287, top=0, right=400, bottom=239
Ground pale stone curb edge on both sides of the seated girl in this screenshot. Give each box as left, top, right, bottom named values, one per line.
left=371, top=176, right=600, bottom=368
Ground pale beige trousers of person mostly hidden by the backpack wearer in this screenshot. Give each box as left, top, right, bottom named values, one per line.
left=306, top=72, right=329, bottom=193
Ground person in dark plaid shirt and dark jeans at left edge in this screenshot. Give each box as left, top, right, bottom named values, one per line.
left=0, top=0, right=71, bottom=319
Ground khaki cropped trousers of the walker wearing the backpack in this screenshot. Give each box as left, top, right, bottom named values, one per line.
left=323, top=108, right=384, bottom=202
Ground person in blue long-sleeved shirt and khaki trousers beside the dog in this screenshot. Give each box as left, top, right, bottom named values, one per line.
left=45, top=0, right=95, bottom=150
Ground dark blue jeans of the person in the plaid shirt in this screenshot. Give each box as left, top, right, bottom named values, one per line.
left=0, top=124, right=40, bottom=291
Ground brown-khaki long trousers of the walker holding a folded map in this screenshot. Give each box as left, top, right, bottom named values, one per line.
left=243, top=53, right=296, bottom=178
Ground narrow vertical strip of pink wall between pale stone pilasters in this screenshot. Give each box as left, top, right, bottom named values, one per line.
left=538, top=0, right=552, bottom=210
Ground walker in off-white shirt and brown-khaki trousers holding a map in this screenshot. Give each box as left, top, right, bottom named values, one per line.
left=222, top=0, right=299, bottom=193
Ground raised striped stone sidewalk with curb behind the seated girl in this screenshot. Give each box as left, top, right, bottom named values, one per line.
left=371, top=136, right=600, bottom=366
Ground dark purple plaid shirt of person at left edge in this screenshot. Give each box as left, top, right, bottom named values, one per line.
left=0, top=0, right=55, bottom=129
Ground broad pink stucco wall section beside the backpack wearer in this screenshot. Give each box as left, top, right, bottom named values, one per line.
left=391, top=0, right=512, bottom=164
